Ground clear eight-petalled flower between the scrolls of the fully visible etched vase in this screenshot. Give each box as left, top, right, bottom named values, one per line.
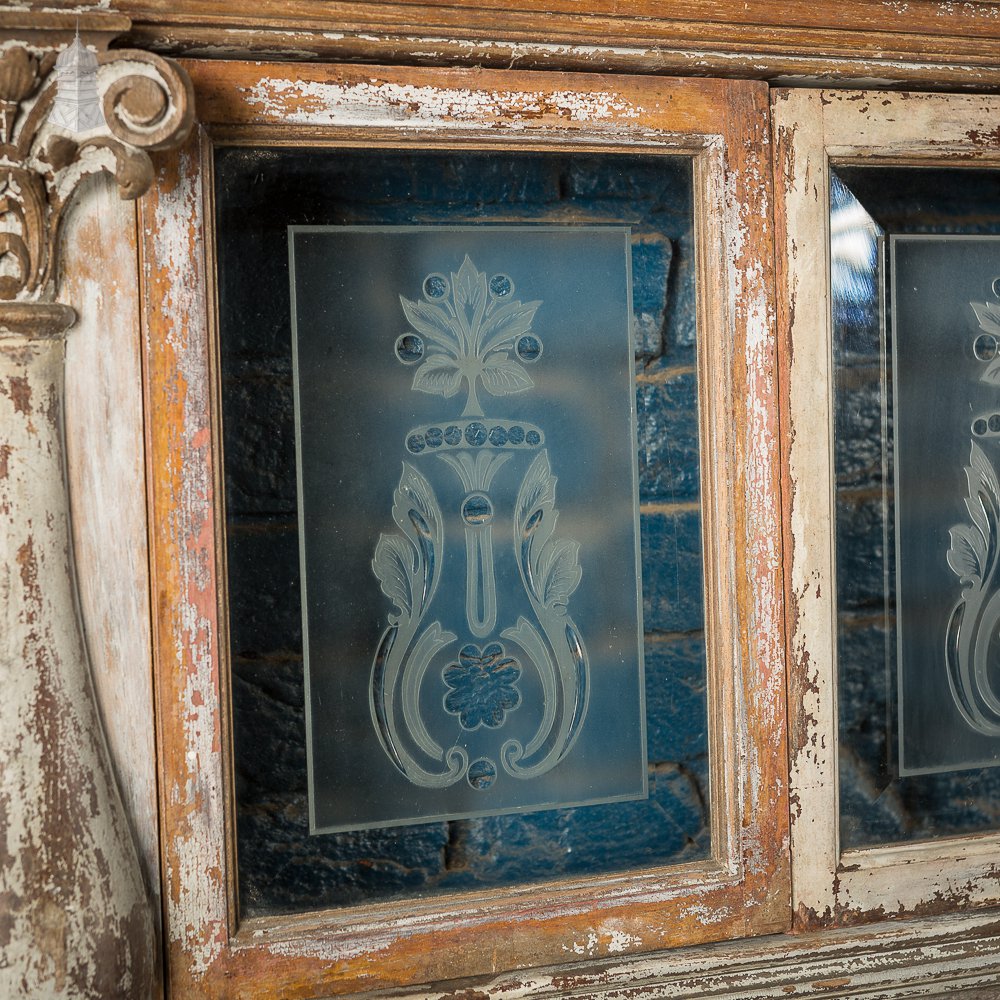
left=442, top=642, right=521, bottom=730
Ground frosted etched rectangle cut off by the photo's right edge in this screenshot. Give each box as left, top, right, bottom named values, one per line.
left=890, top=236, right=1000, bottom=774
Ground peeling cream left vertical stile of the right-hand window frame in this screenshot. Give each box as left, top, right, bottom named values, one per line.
left=772, top=91, right=839, bottom=936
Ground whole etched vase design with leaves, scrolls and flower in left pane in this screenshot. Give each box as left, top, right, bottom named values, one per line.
left=369, top=255, right=590, bottom=794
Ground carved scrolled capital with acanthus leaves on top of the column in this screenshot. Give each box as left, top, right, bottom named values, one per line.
left=0, top=15, right=194, bottom=302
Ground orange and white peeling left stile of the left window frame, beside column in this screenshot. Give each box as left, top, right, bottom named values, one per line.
left=140, top=132, right=229, bottom=984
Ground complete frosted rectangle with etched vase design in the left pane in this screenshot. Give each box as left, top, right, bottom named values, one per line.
left=289, top=226, right=646, bottom=833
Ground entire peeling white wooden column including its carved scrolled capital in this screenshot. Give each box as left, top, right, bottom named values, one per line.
left=0, top=23, right=193, bottom=998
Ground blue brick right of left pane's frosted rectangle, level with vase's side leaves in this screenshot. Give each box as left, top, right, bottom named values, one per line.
left=640, top=510, right=705, bottom=632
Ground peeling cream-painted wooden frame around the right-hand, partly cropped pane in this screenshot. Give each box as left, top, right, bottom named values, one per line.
left=772, top=91, right=1000, bottom=927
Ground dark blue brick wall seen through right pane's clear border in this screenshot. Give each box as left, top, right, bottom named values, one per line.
left=834, top=167, right=1000, bottom=848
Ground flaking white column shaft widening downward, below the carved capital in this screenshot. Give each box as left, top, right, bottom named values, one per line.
left=0, top=303, right=158, bottom=1000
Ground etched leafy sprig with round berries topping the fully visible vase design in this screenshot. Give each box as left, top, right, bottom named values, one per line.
left=396, top=255, right=542, bottom=416
